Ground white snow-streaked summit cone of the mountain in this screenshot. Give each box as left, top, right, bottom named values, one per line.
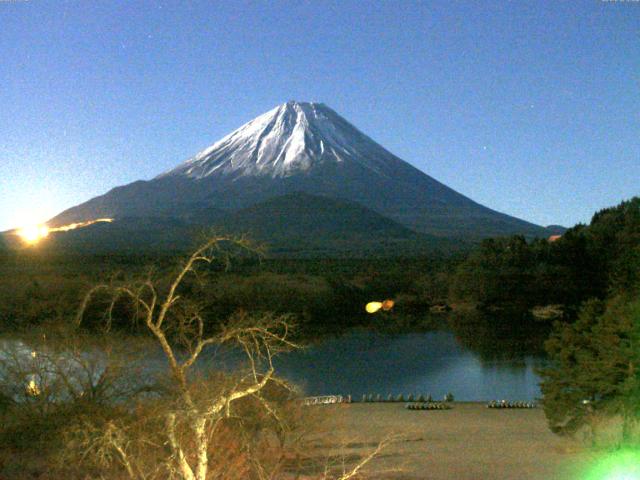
left=158, top=101, right=397, bottom=179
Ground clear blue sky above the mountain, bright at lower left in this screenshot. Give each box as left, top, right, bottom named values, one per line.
left=0, top=0, right=640, bottom=230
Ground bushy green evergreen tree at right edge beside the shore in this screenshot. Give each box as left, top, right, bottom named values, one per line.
left=540, top=295, right=640, bottom=441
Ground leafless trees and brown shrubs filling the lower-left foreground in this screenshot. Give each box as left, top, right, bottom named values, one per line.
left=0, top=237, right=384, bottom=480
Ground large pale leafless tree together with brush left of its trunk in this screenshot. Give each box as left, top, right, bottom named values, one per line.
left=76, top=237, right=297, bottom=480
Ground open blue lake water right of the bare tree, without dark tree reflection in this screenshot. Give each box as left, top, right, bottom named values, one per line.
left=276, top=331, right=544, bottom=401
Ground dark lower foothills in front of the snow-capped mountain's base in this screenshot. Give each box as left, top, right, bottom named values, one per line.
left=5, top=192, right=467, bottom=257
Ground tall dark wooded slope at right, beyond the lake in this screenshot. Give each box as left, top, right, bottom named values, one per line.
left=450, top=197, right=640, bottom=310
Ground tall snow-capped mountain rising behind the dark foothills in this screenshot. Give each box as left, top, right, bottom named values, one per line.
left=48, top=101, right=549, bottom=251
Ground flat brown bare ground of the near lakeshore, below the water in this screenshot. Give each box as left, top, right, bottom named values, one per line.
left=0, top=403, right=597, bottom=480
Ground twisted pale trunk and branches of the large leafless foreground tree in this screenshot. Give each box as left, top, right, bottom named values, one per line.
left=69, top=236, right=298, bottom=480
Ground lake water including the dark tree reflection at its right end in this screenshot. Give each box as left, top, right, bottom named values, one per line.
left=0, top=321, right=543, bottom=401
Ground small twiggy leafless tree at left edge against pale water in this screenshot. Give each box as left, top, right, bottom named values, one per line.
left=0, top=331, right=149, bottom=416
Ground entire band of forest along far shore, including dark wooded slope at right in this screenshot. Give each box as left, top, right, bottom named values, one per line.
left=0, top=198, right=640, bottom=338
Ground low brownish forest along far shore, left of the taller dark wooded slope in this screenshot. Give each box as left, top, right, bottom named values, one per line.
left=0, top=250, right=460, bottom=336
